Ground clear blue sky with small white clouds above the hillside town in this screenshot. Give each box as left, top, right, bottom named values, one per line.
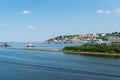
left=0, top=0, right=120, bottom=41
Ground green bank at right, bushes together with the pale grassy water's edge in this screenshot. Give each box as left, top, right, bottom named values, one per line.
left=62, top=43, right=120, bottom=58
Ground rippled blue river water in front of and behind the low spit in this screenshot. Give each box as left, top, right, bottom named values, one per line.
left=0, top=43, right=120, bottom=80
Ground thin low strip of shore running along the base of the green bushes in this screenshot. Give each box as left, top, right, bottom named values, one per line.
left=10, top=48, right=120, bottom=58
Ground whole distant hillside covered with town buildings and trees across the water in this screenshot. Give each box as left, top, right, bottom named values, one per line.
left=45, top=32, right=120, bottom=43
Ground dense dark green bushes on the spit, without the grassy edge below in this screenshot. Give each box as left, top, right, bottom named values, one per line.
left=63, top=43, right=120, bottom=54
